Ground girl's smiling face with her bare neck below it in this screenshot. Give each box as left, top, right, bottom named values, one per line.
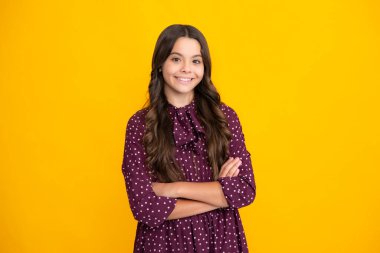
left=162, top=37, right=204, bottom=102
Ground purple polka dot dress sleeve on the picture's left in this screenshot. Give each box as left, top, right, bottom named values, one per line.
left=122, top=113, right=176, bottom=227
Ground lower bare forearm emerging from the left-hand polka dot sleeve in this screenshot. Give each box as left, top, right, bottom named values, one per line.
left=167, top=199, right=218, bottom=220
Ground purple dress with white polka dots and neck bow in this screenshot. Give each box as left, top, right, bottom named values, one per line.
left=122, top=100, right=256, bottom=253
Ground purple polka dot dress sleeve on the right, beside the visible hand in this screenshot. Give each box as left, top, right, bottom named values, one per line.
left=217, top=106, right=256, bottom=208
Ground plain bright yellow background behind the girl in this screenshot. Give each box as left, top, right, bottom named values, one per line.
left=0, top=0, right=380, bottom=253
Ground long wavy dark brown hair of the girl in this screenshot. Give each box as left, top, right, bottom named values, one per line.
left=143, top=24, right=231, bottom=182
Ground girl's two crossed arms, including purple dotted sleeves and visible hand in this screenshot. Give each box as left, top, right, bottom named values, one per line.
left=122, top=106, right=256, bottom=227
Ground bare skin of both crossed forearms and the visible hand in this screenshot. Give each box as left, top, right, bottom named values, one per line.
left=152, top=157, right=242, bottom=220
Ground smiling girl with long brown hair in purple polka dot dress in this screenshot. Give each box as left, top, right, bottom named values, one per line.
left=122, top=25, right=256, bottom=252
